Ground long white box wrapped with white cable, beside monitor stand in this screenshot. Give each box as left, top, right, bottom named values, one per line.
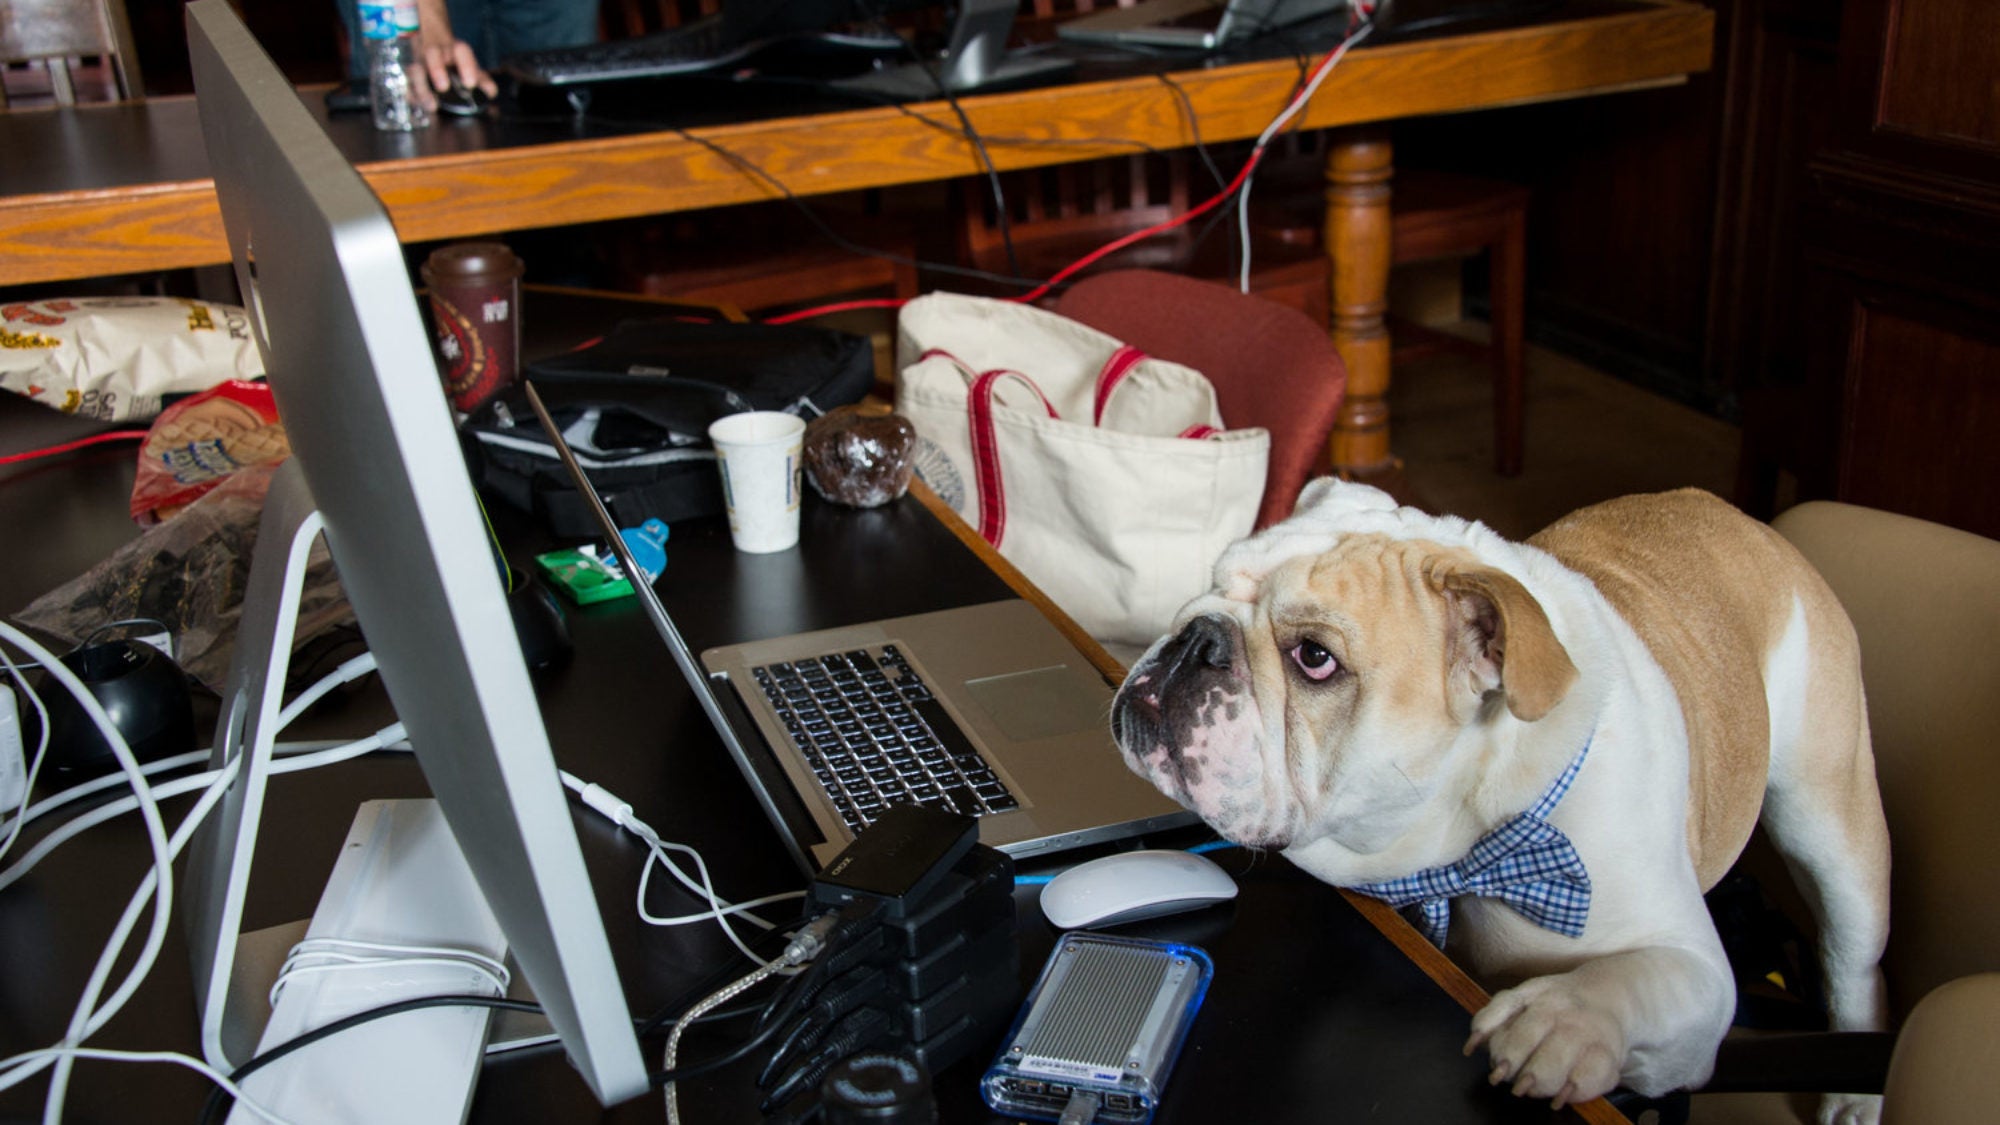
left=230, top=801, right=506, bottom=1125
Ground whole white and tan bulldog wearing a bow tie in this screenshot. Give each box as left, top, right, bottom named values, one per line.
left=1112, top=480, right=1888, bottom=1121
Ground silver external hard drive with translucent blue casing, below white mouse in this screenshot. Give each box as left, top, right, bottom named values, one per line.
left=980, top=933, right=1214, bottom=1125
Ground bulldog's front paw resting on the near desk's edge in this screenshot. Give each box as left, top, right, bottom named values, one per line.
left=1466, top=977, right=1626, bottom=1109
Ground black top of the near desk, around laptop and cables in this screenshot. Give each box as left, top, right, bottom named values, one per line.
left=0, top=366, right=1600, bottom=1123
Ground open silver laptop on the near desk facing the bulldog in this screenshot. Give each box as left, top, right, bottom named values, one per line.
left=526, top=382, right=1194, bottom=873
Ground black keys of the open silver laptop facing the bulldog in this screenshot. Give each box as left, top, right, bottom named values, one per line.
left=754, top=645, right=1020, bottom=833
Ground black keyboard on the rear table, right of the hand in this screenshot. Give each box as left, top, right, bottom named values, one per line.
left=502, top=16, right=902, bottom=86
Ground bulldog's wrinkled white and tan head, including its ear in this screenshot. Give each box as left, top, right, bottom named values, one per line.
left=1112, top=476, right=1574, bottom=879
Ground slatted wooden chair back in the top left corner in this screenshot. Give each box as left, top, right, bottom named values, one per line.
left=0, top=0, right=144, bottom=108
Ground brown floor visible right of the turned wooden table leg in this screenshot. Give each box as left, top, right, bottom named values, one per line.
left=1390, top=324, right=1740, bottom=538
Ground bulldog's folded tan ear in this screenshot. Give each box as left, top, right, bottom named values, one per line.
left=1436, top=567, right=1576, bottom=723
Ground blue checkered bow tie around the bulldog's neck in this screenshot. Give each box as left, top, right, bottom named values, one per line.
left=1348, top=743, right=1590, bottom=949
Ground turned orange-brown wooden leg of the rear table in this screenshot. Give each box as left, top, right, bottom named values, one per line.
left=1326, top=128, right=1396, bottom=478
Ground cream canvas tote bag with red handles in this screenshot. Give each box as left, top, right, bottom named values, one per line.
left=896, top=292, right=1270, bottom=649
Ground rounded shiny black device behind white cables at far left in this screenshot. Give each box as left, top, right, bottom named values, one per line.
left=36, top=639, right=194, bottom=781
